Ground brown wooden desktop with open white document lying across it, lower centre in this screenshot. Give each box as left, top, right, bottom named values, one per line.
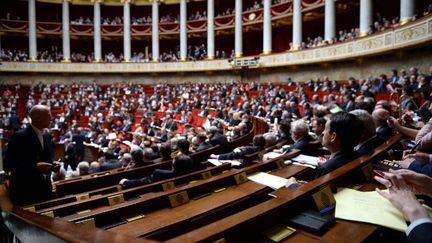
left=110, top=159, right=308, bottom=241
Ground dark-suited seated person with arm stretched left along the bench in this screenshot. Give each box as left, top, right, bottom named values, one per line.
left=119, top=154, right=193, bottom=188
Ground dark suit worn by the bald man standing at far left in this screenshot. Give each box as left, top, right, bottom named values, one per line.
left=5, top=125, right=52, bottom=205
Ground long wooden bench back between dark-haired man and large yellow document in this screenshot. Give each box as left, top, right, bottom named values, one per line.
left=167, top=134, right=401, bottom=242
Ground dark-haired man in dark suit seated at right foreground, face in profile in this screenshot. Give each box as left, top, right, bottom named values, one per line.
left=286, top=112, right=363, bottom=188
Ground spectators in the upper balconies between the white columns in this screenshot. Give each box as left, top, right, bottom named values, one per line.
left=0, top=5, right=432, bottom=63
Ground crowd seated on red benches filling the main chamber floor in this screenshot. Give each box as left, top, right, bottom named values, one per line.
left=0, top=63, right=432, bottom=241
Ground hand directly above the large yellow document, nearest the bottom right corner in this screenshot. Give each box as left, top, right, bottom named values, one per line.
left=374, top=173, right=429, bottom=222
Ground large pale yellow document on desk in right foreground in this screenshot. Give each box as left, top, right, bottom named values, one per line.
left=334, top=188, right=407, bottom=232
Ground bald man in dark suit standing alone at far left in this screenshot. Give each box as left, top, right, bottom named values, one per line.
left=5, top=105, right=60, bottom=206
